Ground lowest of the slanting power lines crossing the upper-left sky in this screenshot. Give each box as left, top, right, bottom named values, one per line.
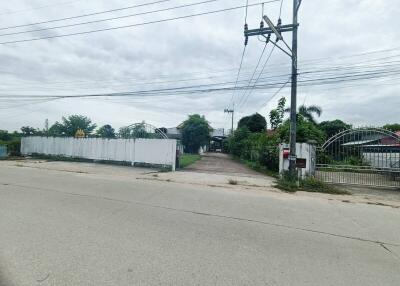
left=0, top=0, right=279, bottom=45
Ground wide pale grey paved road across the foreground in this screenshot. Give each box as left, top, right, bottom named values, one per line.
left=0, top=163, right=400, bottom=286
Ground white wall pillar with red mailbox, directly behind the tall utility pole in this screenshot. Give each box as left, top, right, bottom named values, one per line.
left=279, top=143, right=316, bottom=179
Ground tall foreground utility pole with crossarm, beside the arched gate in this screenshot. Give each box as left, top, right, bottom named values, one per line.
left=244, top=0, right=302, bottom=179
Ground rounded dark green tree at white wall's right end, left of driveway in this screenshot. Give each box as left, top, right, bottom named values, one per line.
left=181, top=114, right=212, bottom=153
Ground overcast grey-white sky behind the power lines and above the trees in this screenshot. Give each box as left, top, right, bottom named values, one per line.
left=0, top=0, right=400, bottom=131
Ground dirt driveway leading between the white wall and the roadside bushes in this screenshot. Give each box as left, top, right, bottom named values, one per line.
left=185, top=153, right=260, bottom=177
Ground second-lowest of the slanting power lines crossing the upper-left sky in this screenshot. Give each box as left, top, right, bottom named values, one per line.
left=0, top=0, right=220, bottom=37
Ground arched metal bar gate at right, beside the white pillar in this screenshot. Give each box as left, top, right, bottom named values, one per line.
left=315, top=127, right=400, bottom=187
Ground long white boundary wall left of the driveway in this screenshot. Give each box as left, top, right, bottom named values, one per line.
left=21, top=137, right=176, bottom=170
